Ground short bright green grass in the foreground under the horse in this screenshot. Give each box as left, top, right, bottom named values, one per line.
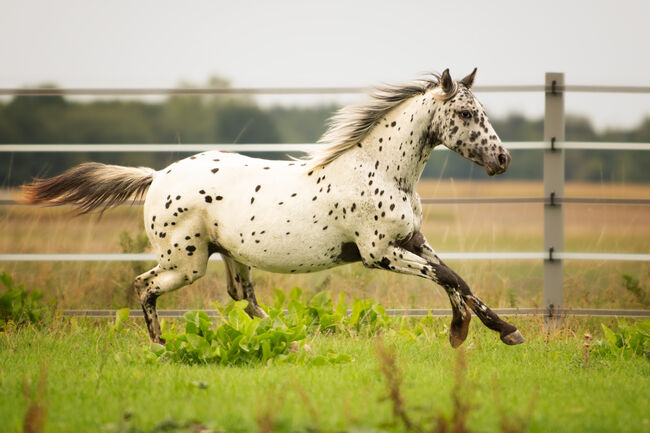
left=0, top=318, right=650, bottom=432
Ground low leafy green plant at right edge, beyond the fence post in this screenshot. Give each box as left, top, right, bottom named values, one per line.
left=595, top=319, right=650, bottom=359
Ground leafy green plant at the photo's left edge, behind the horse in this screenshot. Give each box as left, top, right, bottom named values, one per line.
left=0, top=272, right=46, bottom=330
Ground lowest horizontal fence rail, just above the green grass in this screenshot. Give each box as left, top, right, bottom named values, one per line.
left=63, top=308, right=650, bottom=318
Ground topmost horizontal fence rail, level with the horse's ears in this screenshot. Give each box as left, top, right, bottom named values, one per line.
left=0, top=84, right=650, bottom=96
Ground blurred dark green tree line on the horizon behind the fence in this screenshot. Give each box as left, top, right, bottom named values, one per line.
left=0, top=88, right=650, bottom=187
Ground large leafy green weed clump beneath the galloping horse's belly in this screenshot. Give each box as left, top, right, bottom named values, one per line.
left=145, top=287, right=393, bottom=365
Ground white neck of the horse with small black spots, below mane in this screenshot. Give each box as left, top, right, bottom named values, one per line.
left=357, top=94, right=435, bottom=192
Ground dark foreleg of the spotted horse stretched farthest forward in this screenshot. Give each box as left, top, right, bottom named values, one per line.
left=403, top=232, right=524, bottom=345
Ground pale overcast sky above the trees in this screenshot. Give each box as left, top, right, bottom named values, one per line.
left=0, top=0, right=650, bottom=130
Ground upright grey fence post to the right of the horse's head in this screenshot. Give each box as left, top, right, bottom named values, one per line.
left=544, top=72, right=565, bottom=321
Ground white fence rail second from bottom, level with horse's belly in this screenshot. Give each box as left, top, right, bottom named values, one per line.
left=0, top=251, right=650, bottom=262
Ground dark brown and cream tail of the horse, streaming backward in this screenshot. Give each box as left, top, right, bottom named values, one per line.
left=21, top=162, right=156, bottom=214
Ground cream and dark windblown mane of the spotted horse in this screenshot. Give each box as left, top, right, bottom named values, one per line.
left=307, top=74, right=456, bottom=169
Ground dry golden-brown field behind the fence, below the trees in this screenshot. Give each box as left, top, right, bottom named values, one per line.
left=0, top=181, right=650, bottom=308
